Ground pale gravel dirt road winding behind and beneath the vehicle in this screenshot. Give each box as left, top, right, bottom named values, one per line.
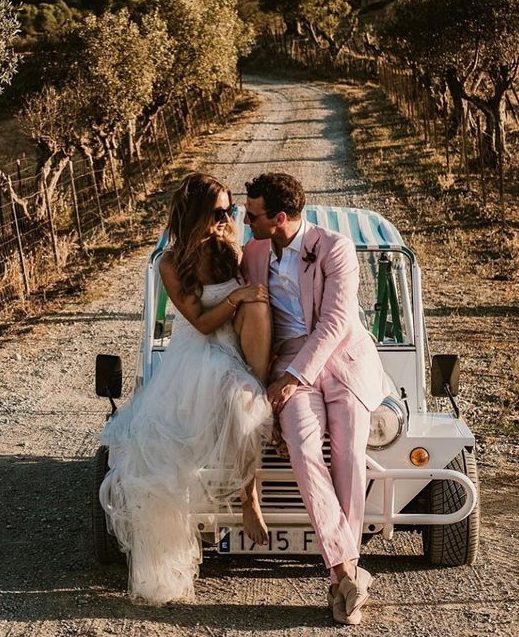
left=0, top=80, right=519, bottom=637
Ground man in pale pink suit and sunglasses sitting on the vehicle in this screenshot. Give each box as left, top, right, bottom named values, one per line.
left=243, top=173, right=387, bottom=624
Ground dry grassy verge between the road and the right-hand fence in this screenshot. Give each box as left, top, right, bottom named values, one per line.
left=338, top=79, right=519, bottom=440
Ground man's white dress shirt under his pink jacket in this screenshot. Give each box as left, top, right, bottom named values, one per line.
left=269, top=219, right=308, bottom=384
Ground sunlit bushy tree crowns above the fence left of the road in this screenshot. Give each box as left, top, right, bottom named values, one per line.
left=21, top=0, right=246, bottom=166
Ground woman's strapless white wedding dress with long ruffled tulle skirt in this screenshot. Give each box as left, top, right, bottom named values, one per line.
left=99, top=279, right=272, bottom=605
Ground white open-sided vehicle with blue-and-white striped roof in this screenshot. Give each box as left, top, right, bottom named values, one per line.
left=93, top=206, right=479, bottom=566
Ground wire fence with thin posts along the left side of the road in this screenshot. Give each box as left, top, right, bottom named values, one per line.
left=0, top=86, right=236, bottom=310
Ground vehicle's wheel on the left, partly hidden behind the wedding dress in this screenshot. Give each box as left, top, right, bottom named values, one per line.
left=92, top=447, right=126, bottom=564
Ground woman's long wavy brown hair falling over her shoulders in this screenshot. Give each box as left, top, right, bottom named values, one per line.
left=167, top=173, right=239, bottom=295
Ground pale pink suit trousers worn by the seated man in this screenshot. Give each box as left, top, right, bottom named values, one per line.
left=272, top=339, right=370, bottom=582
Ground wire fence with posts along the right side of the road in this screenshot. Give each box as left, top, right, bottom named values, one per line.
left=264, top=27, right=519, bottom=214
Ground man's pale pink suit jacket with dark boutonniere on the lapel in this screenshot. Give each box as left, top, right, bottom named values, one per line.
left=242, top=222, right=389, bottom=411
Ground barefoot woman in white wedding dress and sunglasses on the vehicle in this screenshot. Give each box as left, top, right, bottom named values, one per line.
left=99, top=173, right=272, bottom=605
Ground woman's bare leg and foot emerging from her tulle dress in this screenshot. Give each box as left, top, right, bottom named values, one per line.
left=234, top=303, right=272, bottom=544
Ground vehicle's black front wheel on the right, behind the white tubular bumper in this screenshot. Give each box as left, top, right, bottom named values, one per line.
left=422, top=449, right=479, bottom=566
